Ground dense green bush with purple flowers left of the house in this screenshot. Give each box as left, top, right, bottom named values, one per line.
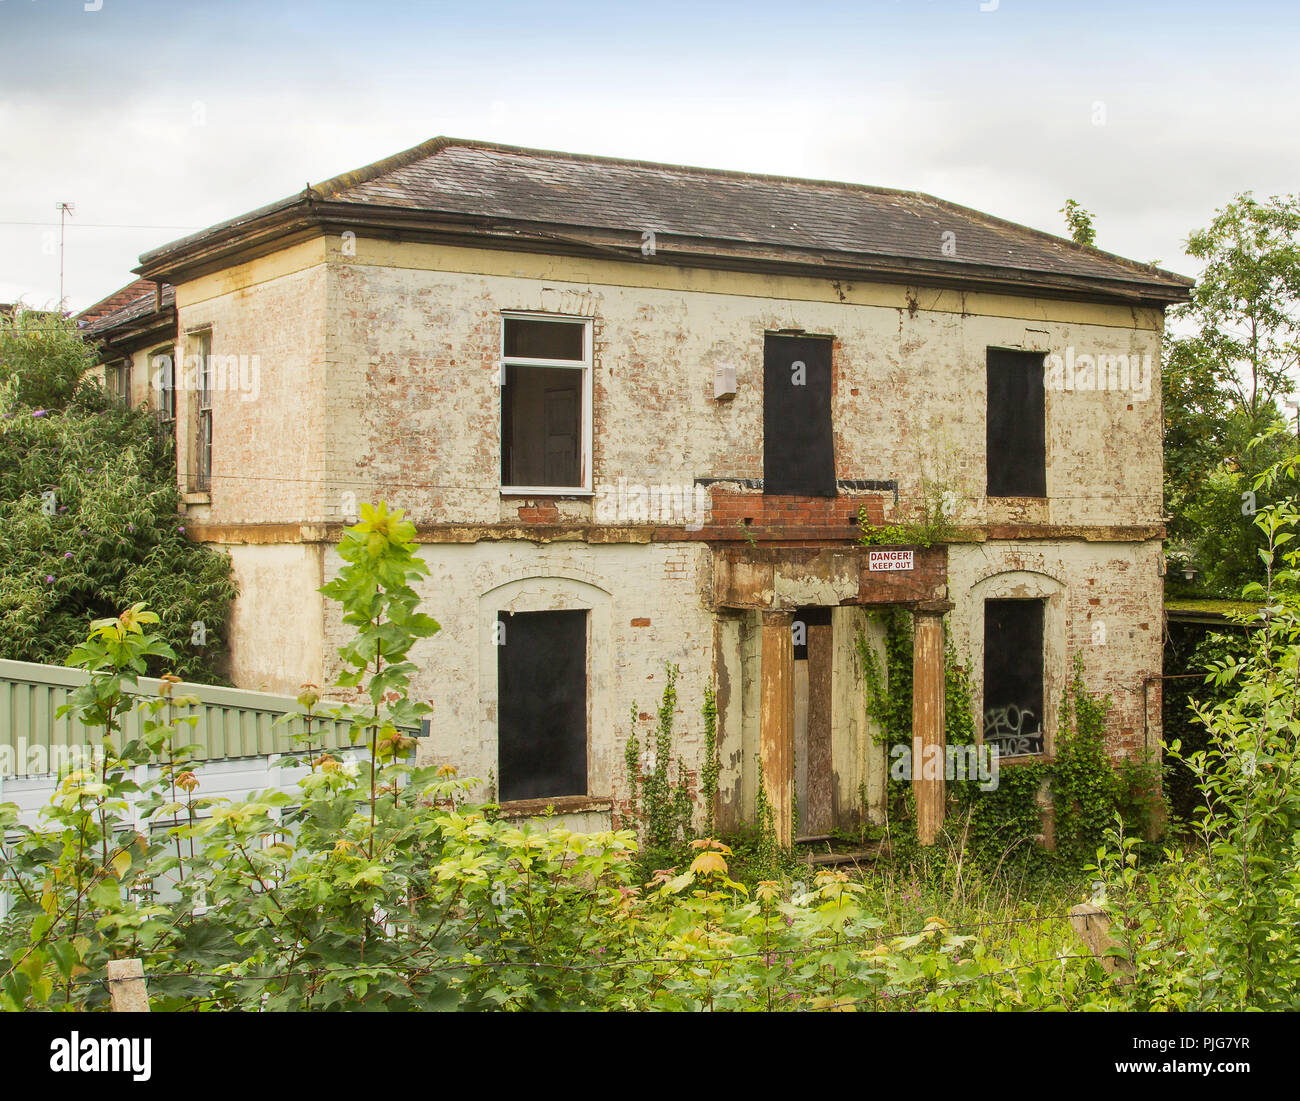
left=0, top=312, right=235, bottom=681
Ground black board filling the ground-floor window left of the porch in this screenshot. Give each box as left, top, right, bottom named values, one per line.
left=497, top=611, right=588, bottom=802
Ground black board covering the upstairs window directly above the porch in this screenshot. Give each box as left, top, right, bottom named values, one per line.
left=763, top=333, right=836, bottom=497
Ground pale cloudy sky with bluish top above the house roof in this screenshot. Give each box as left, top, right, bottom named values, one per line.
left=0, top=0, right=1300, bottom=309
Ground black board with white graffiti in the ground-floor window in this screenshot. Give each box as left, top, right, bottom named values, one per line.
left=984, top=601, right=1044, bottom=755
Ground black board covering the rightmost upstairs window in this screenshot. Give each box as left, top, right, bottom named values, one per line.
left=987, top=348, right=1047, bottom=497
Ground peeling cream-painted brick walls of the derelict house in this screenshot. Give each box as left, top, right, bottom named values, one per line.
left=157, top=237, right=1162, bottom=824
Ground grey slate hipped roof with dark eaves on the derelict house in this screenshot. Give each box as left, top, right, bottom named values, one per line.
left=137, top=138, right=1192, bottom=305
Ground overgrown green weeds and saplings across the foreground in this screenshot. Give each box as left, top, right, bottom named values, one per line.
left=0, top=506, right=1300, bottom=1011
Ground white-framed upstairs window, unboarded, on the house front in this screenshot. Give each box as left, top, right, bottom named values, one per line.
left=498, top=312, right=592, bottom=494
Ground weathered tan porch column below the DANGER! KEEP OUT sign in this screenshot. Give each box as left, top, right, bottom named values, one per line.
left=911, top=601, right=952, bottom=845
